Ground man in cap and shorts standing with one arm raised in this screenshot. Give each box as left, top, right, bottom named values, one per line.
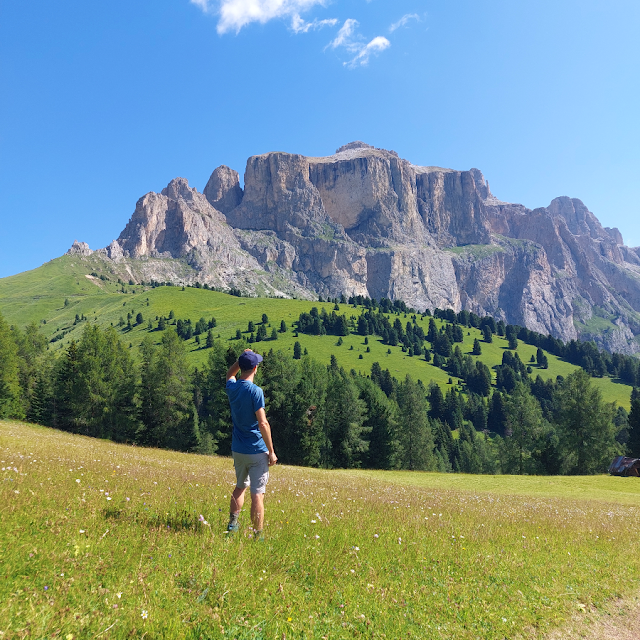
left=226, top=349, right=278, bottom=540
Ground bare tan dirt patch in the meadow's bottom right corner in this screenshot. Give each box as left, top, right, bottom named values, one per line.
left=544, top=597, right=640, bottom=640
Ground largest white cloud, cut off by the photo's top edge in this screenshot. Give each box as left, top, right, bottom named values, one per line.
left=190, top=0, right=330, bottom=34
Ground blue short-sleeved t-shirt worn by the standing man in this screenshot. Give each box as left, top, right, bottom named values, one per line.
left=226, top=380, right=269, bottom=453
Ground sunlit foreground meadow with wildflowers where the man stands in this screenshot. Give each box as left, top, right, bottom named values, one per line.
left=0, top=421, right=640, bottom=640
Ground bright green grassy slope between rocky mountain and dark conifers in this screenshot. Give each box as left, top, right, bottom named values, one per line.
left=0, top=256, right=630, bottom=408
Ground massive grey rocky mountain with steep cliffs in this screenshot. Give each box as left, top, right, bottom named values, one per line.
left=70, top=142, right=640, bottom=353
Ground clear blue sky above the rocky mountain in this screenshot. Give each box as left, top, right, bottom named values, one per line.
left=0, top=0, right=640, bottom=277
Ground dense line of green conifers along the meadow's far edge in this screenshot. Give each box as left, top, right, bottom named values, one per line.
left=0, top=316, right=640, bottom=474
